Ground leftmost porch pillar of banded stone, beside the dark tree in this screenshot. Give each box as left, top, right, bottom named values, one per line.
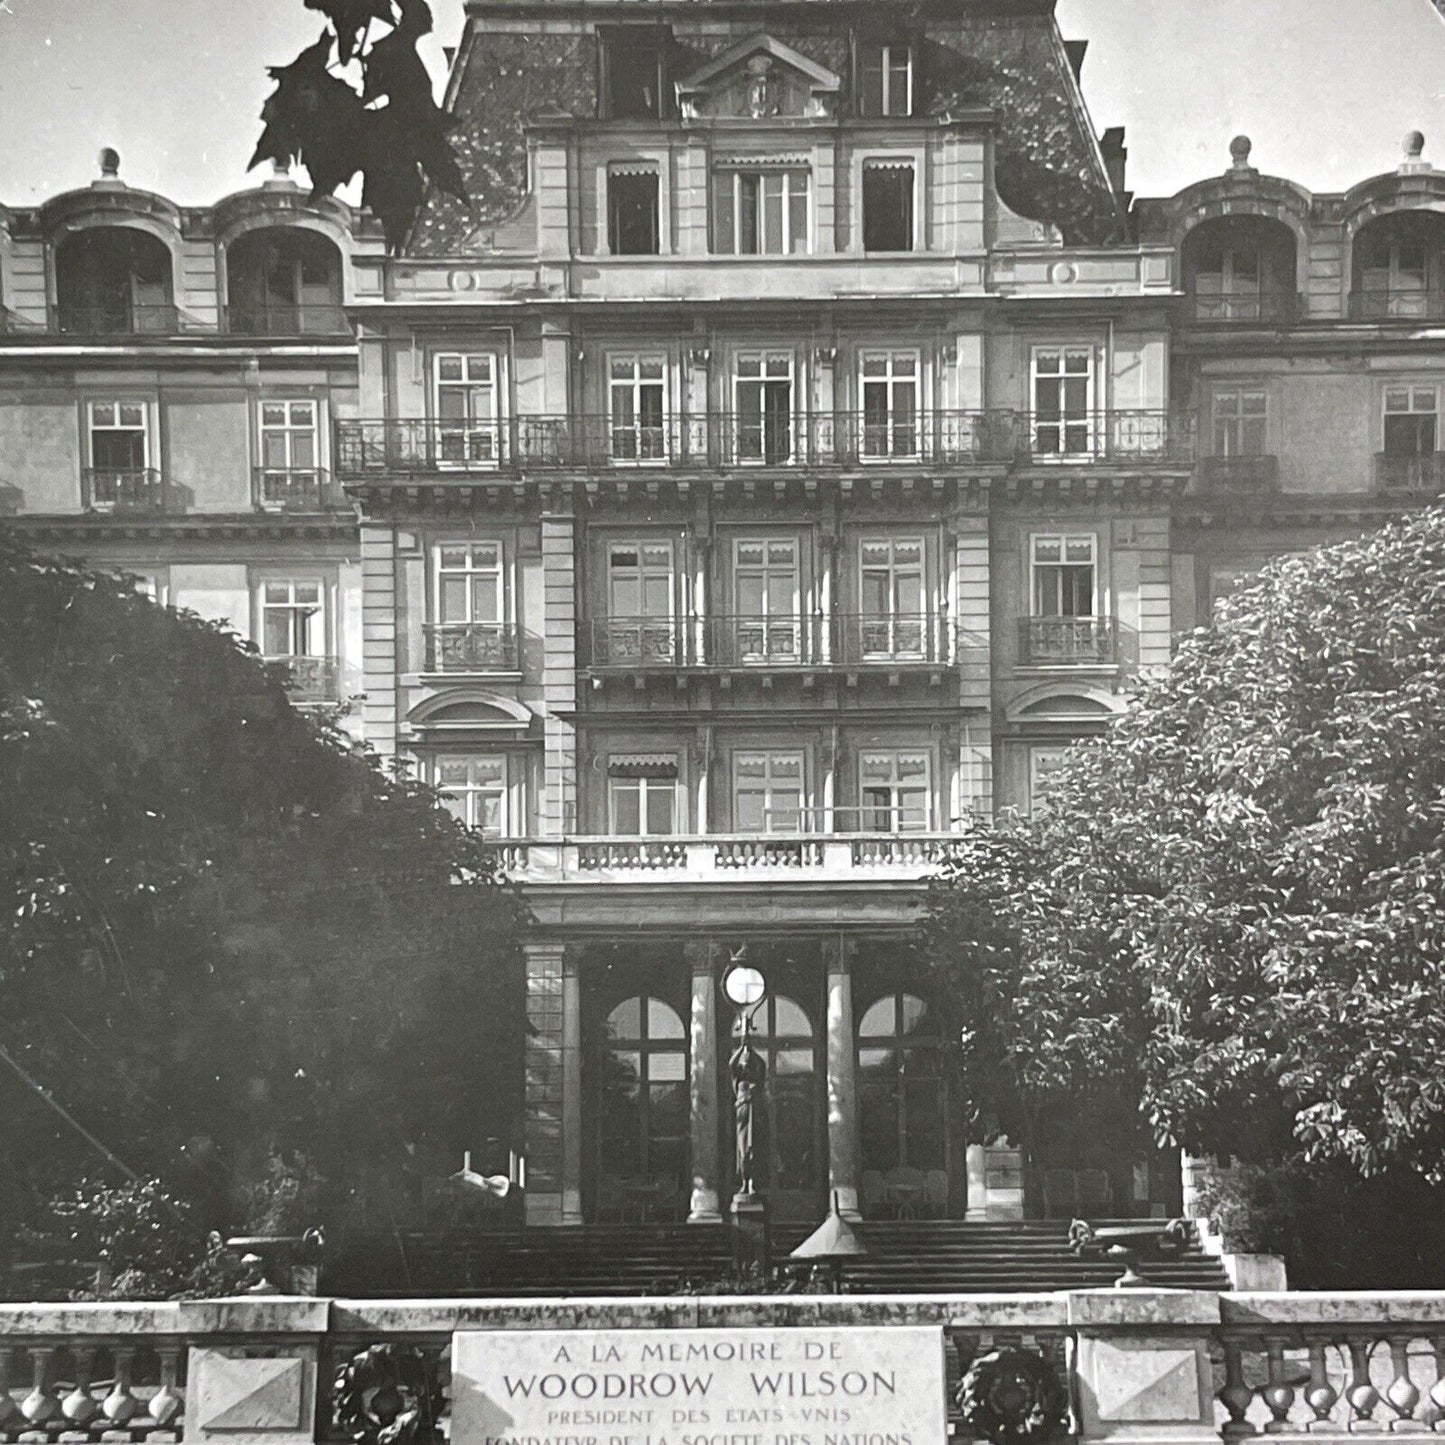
left=522, top=942, right=582, bottom=1225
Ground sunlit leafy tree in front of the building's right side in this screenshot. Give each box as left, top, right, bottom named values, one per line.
left=923, top=509, right=1445, bottom=1179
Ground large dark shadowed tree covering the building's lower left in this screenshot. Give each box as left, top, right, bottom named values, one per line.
left=0, top=533, right=522, bottom=1242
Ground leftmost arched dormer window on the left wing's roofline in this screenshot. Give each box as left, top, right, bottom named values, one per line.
left=55, top=225, right=178, bottom=337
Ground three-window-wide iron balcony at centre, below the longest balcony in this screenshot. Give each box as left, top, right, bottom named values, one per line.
left=582, top=613, right=957, bottom=672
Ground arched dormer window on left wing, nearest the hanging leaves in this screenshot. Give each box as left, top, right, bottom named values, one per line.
left=225, top=225, right=347, bottom=337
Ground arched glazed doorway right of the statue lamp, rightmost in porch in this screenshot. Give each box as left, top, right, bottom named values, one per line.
left=858, top=991, right=948, bottom=1218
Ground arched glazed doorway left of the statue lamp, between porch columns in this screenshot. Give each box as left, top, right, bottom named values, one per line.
left=595, top=994, right=689, bottom=1221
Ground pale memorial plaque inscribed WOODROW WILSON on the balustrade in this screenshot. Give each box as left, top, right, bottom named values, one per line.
left=451, top=1325, right=945, bottom=1445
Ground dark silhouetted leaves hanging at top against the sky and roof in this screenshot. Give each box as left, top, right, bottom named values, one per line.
left=250, top=0, right=471, bottom=251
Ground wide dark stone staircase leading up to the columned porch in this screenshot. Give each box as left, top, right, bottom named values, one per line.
left=321, top=1220, right=1230, bottom=1298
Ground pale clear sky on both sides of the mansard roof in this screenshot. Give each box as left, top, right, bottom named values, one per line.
left=0, top=0, right=1445, bottom=207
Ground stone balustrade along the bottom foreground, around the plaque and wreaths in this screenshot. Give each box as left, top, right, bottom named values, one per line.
left=0, top=1290, right=1445, bottom=1445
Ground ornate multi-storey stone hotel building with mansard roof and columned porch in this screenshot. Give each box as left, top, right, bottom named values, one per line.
left=0, top=0, right=1445, bottom=1225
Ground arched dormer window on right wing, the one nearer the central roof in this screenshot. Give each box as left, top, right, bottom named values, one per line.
left=1183, top=215, right=1295, bottom=321
